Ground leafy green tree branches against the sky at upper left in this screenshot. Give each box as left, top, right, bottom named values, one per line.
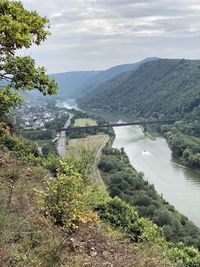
left=0, top=0, right=57, bottom=116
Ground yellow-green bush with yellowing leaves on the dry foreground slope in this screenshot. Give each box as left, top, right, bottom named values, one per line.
left=39, top=162, right=98, bottom=231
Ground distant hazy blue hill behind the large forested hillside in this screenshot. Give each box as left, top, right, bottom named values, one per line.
left=50, top=58, right=157, bottom=98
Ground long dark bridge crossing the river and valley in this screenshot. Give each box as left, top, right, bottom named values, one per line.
left=57, top=119, right=175, bottom=132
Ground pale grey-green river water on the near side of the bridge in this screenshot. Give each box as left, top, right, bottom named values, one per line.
left=113, top=126, right=200, bottom=227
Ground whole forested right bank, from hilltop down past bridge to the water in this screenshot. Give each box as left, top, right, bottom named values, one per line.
left=79, top=59, right=200, bottom=168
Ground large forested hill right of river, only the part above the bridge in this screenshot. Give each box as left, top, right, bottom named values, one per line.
left=79, top=59, right=200, bottom=118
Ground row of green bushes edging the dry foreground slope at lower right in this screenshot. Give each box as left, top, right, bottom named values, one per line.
left=95, top=197, right=200, bottom=267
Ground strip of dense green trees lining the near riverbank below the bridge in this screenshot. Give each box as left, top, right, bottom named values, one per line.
left=99, top=146, right=200, bottom=248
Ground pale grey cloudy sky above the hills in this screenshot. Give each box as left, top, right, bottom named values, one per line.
left=21, top=0, right=200, bottom=73
